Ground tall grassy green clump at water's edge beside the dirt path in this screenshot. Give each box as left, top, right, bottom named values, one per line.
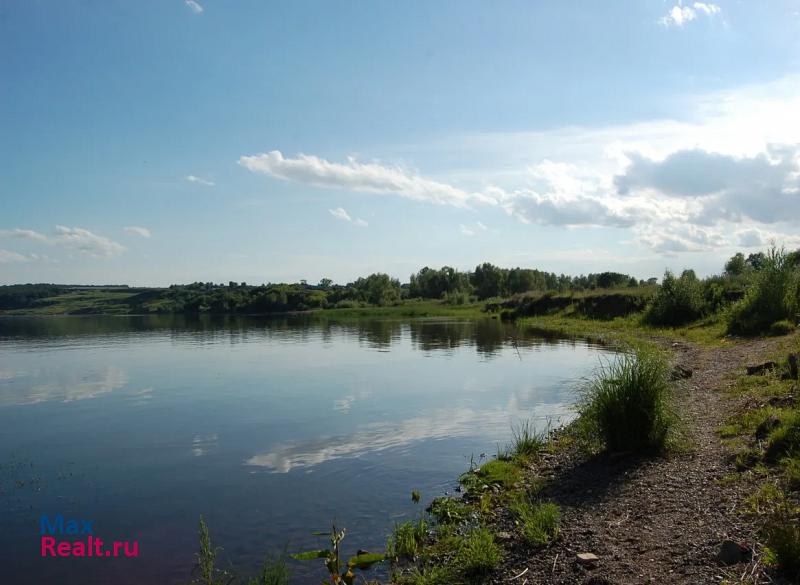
left=579, top=348, right=674, bottom=451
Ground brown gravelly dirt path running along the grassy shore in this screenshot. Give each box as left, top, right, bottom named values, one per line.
left=494, top=340, right=788, bottom=585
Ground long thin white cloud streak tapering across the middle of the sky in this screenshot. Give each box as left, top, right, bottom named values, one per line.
left=239, top=150, right=494, bottom=207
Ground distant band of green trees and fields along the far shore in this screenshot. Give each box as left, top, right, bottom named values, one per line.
left=0, top=263, right=640, bottom=315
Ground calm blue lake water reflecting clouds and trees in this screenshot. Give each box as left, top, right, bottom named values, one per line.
left=0, top=317, right=602, bottom=585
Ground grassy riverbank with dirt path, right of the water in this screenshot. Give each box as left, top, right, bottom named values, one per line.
left=384, top=316, right=800, bottom=584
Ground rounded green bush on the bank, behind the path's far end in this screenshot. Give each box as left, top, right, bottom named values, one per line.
left=644, top=270, right=705, bottom=326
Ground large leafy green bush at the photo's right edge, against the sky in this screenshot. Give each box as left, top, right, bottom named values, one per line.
left=728, top=248, right=800, bottom=335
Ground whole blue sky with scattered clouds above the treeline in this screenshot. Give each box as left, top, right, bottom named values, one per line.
left=0, top=0, right=800, bottom=286
